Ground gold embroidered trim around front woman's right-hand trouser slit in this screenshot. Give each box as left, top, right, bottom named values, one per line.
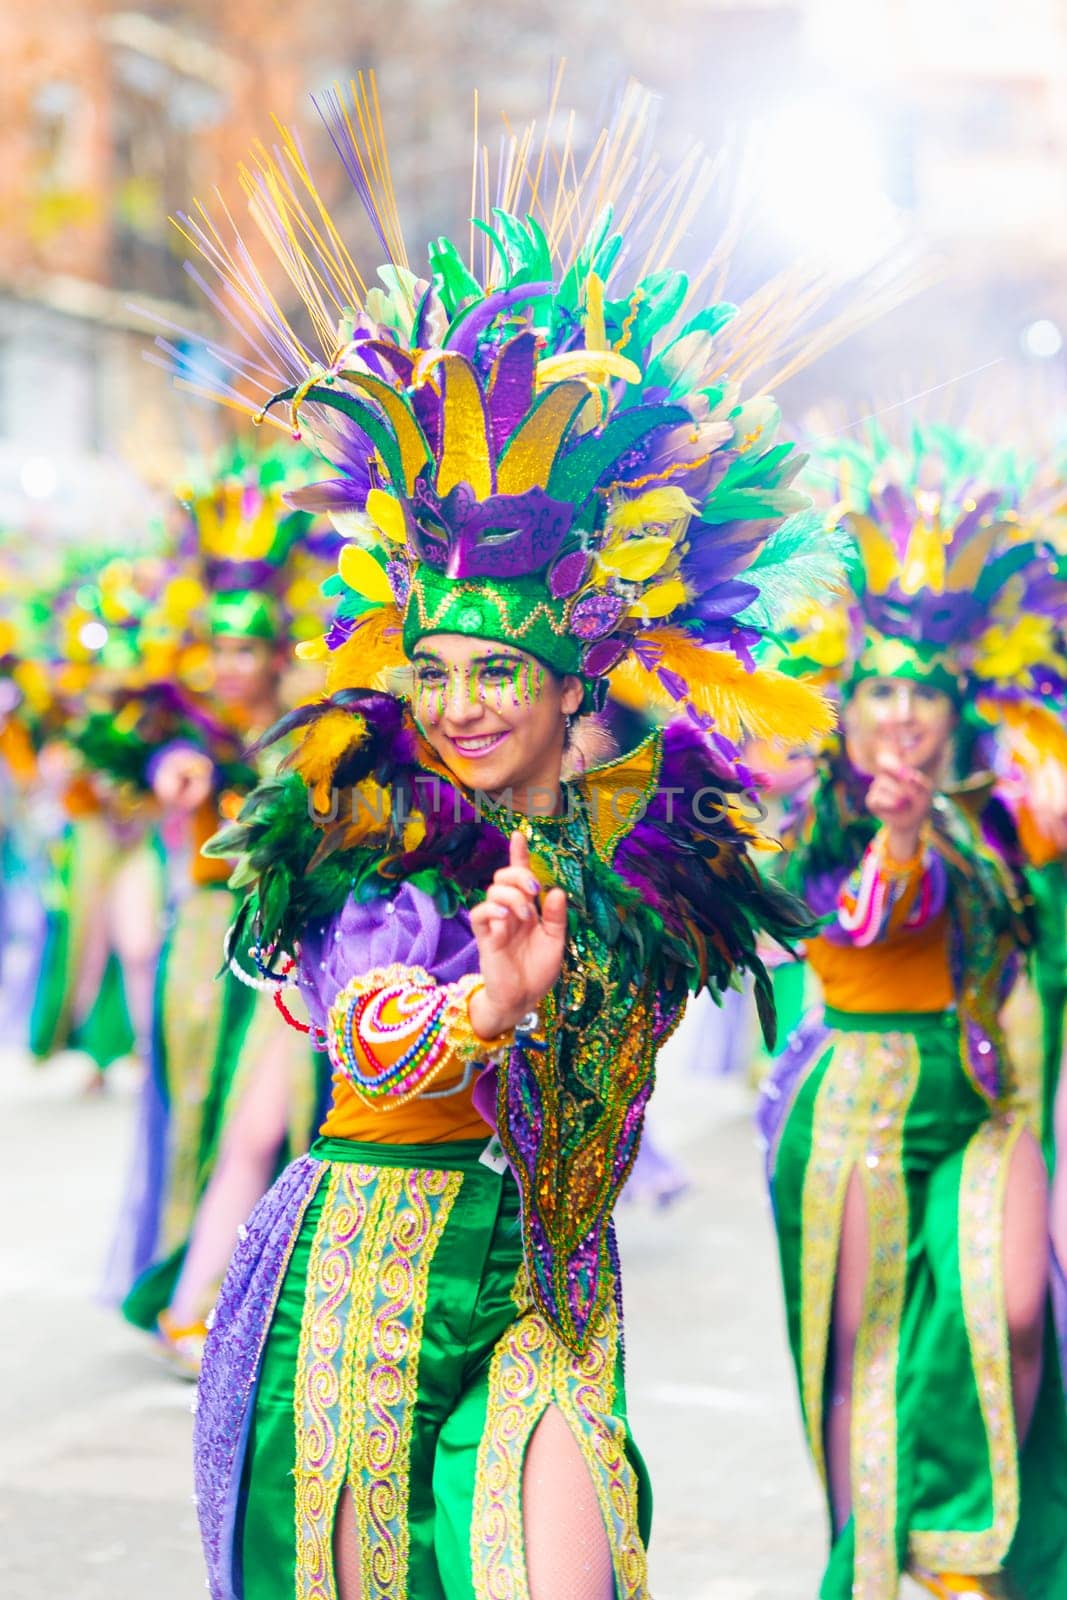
left=470, top=1270, right=648, bottom=1600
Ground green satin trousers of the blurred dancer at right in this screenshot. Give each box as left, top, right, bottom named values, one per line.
left=771, top=1013, right=1067, bottom=1600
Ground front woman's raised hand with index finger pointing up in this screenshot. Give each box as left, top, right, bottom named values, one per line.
left=470, top=832, right=566, bottom=1038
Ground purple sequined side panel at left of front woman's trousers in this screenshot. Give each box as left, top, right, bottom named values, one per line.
left=194, top=1155, right=326, bottom=1600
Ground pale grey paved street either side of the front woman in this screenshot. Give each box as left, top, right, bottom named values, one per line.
left=0, top=1053, right=921, bottom=1600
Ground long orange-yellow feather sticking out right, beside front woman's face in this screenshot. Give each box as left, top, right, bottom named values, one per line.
left=609, top=627, right=837, bottom=746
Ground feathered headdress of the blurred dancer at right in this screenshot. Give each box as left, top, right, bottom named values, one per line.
left=787, top=427, right=1067, bottom=709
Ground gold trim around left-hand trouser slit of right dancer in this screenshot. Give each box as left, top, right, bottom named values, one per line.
left=800, top=1034, right=920, bottom=1600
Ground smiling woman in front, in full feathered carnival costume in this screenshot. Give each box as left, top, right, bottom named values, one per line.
left=160, top=86, right=857, bottom=1600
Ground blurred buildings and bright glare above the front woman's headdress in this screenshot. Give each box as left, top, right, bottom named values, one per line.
left=0, top=0, right=1067, bottom=533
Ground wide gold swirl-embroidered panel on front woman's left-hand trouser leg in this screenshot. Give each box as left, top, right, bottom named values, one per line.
left=296, top=1162, right=462, bottom=1600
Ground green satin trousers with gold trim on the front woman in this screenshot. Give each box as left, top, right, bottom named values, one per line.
left=238, top=1139, right=651, bottom=1600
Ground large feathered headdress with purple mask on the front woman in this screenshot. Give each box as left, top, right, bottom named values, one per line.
left=160, top=80, right=927, bottom=739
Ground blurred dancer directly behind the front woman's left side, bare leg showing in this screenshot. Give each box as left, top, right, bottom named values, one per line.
left=110, top=451, right=323, bottom=1376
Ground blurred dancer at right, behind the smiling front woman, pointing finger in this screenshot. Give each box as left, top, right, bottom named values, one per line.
left=761, top=432, right=1067, bottom=1600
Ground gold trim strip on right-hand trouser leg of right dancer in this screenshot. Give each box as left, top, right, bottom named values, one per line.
left=909, top=1117, right=1025, bottom=1573
